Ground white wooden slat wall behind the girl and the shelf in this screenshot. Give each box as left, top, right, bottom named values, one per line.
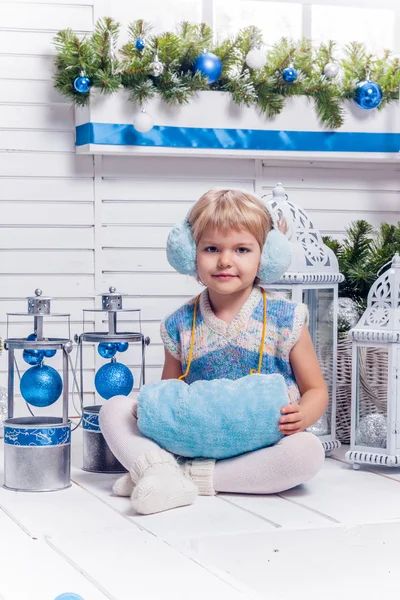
left=0, top=0, right=400, bottom=418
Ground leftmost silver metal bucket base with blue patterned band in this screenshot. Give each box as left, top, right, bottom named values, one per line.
left=4, top=417, right=71, bottom=492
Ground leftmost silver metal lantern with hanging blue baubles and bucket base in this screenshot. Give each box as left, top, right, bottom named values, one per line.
left=4, top=289, right=73, bottom=492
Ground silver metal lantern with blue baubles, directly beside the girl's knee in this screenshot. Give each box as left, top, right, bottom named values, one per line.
left=76, top=287, right=150, bottom=473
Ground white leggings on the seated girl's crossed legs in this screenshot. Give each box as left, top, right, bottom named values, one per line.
left=100, top=396, right=325, bottom=494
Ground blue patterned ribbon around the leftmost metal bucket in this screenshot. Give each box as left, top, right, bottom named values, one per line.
left=4, top=425, right=71, bottom=446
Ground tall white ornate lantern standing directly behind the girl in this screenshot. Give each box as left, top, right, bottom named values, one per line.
left=261, top=183, right=344, bottom=452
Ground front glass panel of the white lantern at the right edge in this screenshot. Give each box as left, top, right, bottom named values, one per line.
left=355, top=346, right=388, bottom=448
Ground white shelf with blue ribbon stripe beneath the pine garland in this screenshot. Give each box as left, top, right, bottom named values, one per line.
left=75, top=91, right=400, bottom=162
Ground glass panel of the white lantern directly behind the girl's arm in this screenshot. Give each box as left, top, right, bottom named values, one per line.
left=303, top=288, right=334, bottom=432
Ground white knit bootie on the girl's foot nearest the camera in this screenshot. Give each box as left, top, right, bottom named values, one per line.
left=130, top=449, right=198, bottom=515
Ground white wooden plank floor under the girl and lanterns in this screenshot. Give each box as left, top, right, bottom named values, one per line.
left=0, top=434, right=400, bottom=600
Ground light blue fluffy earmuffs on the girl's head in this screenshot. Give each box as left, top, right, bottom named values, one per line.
left=167, top=190, right=291, bottom=283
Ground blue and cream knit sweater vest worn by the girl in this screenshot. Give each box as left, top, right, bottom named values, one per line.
left=161, top=286, right=308, bottom=402
